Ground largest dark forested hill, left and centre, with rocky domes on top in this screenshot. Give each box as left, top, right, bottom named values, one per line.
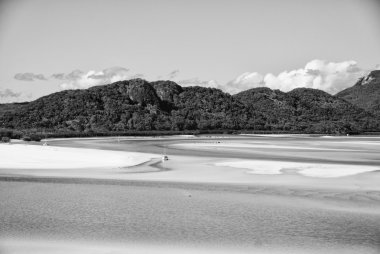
left=0, top=79, right=263, bottom=132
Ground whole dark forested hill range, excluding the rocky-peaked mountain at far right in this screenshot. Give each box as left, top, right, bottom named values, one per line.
left=0, top=79, right=380, bottom=135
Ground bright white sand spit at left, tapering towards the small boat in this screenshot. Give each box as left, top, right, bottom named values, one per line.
left=0, top=144, right=159, bottom=169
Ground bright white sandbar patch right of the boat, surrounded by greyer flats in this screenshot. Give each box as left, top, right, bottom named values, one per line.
left=214, top=160, right=380, bottom=178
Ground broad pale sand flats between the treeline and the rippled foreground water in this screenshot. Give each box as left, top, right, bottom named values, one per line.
left=0, top=136, right=380, bottom=191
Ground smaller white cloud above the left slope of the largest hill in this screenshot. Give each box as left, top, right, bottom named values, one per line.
left=52, top=67, right=134, bottom=89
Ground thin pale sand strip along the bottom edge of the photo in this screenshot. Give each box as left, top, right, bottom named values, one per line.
left=0, top=239, right=377, bottom=254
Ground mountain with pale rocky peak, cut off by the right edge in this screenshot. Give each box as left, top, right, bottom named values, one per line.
left=336, top=70, right=380, bottom=117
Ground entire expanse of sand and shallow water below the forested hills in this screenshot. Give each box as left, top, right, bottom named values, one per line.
left=0, top=135, right=380, bottom=253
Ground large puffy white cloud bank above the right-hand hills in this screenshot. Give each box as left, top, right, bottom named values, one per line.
left=223, top=59, right=368, bottom=94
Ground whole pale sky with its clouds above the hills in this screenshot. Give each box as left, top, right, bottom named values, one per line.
left=0, top=0, right=380, bottom=103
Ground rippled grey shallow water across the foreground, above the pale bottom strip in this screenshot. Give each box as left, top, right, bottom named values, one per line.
left=0, top=182, right=380, bottom=253
